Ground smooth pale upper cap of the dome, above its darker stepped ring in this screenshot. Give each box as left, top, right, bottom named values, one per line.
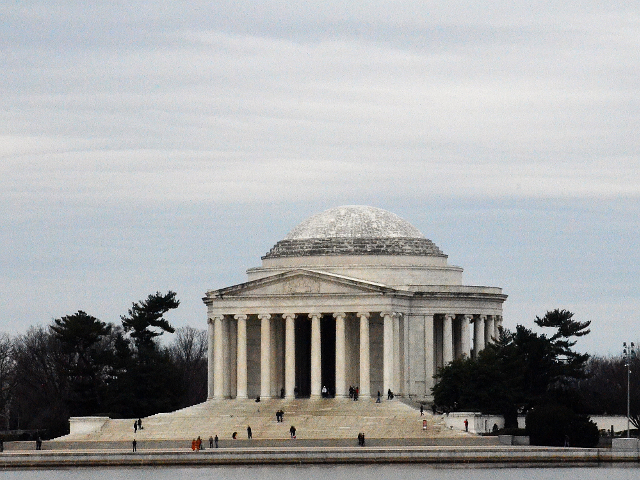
left=285, top=205, right=424, bottom=240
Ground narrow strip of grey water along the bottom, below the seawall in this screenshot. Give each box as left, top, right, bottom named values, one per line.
left=0, top=465, right=640, bottom=480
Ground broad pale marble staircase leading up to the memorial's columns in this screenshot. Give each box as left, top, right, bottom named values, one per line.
left=53, top=398, right=456, bottom=442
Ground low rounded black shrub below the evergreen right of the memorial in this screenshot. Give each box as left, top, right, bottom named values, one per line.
left=526, top=405, right=600, bottom=447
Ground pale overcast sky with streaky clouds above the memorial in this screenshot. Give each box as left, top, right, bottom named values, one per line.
left=0, top=0, right=640, bottom=354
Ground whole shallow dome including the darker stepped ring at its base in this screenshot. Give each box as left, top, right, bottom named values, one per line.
left=262, top=205, right=446, bottom=259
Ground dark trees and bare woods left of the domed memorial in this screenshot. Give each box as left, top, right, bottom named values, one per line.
left=0, top=291, right=207, bottom=438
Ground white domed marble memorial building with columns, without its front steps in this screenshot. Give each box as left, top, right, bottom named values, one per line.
left=203, top=206, right=507, bottom=400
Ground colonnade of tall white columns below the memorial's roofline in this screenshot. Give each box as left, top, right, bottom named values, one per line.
left=208, top=309, right=499, bottom=399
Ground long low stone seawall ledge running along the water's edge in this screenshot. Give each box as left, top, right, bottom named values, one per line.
left=0, top=446, right=640, bottom=469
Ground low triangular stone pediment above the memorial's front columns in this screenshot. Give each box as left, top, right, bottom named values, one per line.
left=209, top=269, right=395, bottom=297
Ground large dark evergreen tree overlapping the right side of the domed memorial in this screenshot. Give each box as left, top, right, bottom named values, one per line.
left=433, top=310, right=590, bottom=428
